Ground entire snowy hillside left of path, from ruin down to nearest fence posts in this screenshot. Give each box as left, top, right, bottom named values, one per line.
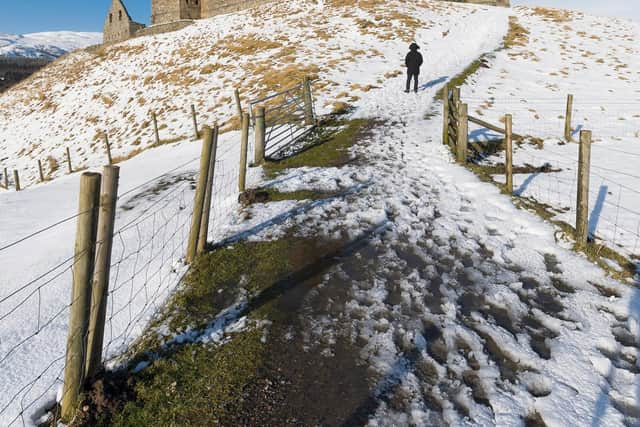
left=0, top=0, right=508, bottom=425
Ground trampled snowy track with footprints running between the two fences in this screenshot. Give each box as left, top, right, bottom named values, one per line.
left=252, top=86, right=640, bottom=425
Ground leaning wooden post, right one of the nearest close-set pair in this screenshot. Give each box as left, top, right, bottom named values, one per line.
left=85, top=166, right=120, bottom=378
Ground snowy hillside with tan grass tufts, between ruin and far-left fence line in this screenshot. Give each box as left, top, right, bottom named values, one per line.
left=0, top=0, right=480, bottom=188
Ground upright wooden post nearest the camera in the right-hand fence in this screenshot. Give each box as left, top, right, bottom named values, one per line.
left=576, top=130, right=591, bottom=250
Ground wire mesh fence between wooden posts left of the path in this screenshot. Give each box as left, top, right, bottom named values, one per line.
left=0, top=78, right=316, bottom=425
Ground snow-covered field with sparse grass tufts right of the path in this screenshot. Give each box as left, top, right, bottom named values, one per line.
left=461, top=7, right=640, bottom=257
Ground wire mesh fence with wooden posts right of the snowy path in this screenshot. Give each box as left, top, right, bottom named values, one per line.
left=449, top=93, right=640, bottom=262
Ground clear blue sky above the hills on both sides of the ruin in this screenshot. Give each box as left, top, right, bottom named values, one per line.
left=0, top=0, right=640, bottom=34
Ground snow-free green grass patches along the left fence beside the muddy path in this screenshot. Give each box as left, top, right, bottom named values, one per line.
left=78, top=120, right=368, bottom=426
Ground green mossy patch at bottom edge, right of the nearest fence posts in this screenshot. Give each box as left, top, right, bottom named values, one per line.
left=112, top=330, right=265, bottom=426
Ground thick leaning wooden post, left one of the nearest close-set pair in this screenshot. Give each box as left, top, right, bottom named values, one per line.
left=61, top=173, right=100, bottom=422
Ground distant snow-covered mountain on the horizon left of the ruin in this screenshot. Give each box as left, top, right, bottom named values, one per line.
left=0, top=31, right=102, bottom=59
